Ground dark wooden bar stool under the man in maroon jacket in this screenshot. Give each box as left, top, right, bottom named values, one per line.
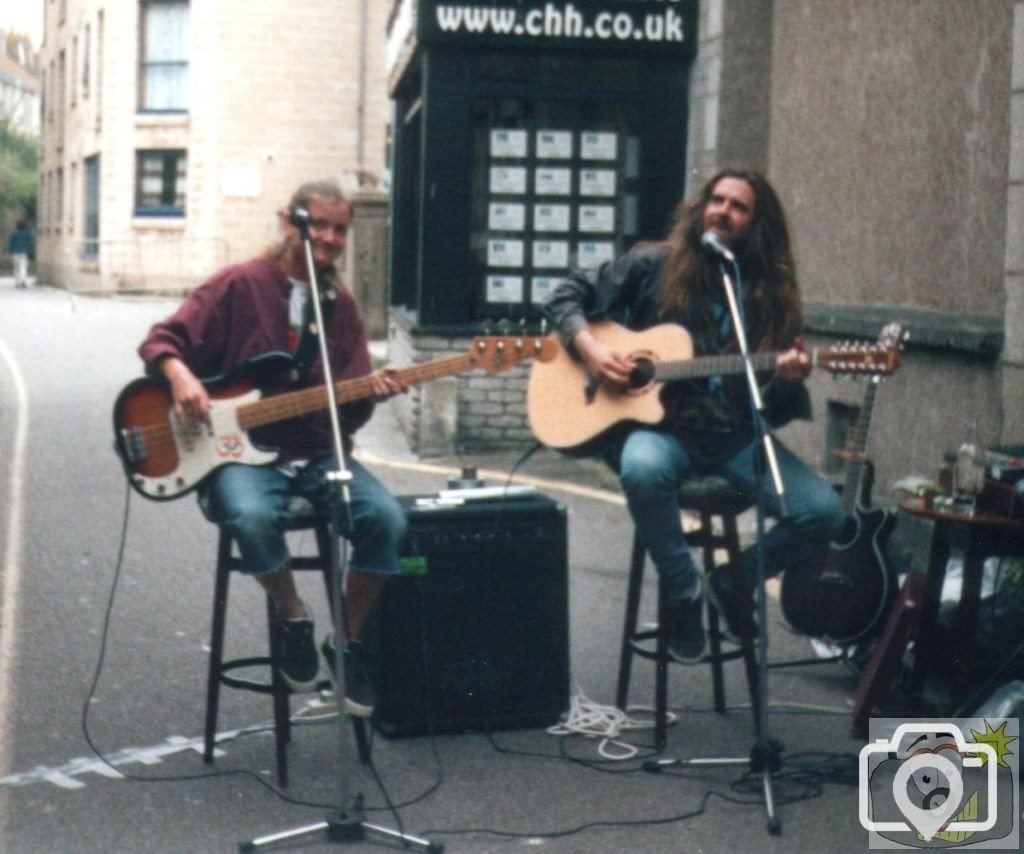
left=201, top=498, right=370, bottom=788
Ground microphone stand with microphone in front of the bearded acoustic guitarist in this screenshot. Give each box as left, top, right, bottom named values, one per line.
left=643, top=250, right=788, bottom=836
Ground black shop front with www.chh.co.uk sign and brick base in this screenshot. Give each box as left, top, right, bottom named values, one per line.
left=388, top=0, right=696, bottom=453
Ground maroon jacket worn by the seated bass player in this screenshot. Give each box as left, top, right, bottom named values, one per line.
left=138, top=258, right=374, bottom=460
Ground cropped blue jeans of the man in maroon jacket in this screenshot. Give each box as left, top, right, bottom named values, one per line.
left=203, top=457, right=407, bottom=575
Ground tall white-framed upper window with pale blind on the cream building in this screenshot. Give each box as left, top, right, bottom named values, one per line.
left=138, top=0, right=188, bottom=112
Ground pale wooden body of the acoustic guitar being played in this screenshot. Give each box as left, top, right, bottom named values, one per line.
left=526, top=322, right=693, bottom=456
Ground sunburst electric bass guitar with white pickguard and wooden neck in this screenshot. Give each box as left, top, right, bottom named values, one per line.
left=114, top=336, right=556, bottom=501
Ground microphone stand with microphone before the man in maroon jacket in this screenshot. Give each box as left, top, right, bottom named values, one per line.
left=239, top=208, right=444, bottom=854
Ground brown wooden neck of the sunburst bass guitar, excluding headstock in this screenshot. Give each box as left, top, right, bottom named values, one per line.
left=238, top=353, right=473, bottom=430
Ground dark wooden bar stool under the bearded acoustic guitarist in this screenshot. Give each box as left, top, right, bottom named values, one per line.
left=615, top=477, right=758, bottom=751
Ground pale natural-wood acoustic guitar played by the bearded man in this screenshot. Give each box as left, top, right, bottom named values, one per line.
left=526, top=321, right=899, bottom=456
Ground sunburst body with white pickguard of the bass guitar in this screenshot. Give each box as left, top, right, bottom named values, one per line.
left=114, top=352, right=292, bottom=501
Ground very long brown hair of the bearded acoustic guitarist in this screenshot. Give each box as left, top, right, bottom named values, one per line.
left=658, top=169, right=804, bottom=349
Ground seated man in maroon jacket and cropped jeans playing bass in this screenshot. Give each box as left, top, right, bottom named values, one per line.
left=139, top=181, right=406, bottom=716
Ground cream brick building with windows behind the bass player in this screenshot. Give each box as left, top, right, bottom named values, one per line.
left=38, top=0, right=388, bottom=313
